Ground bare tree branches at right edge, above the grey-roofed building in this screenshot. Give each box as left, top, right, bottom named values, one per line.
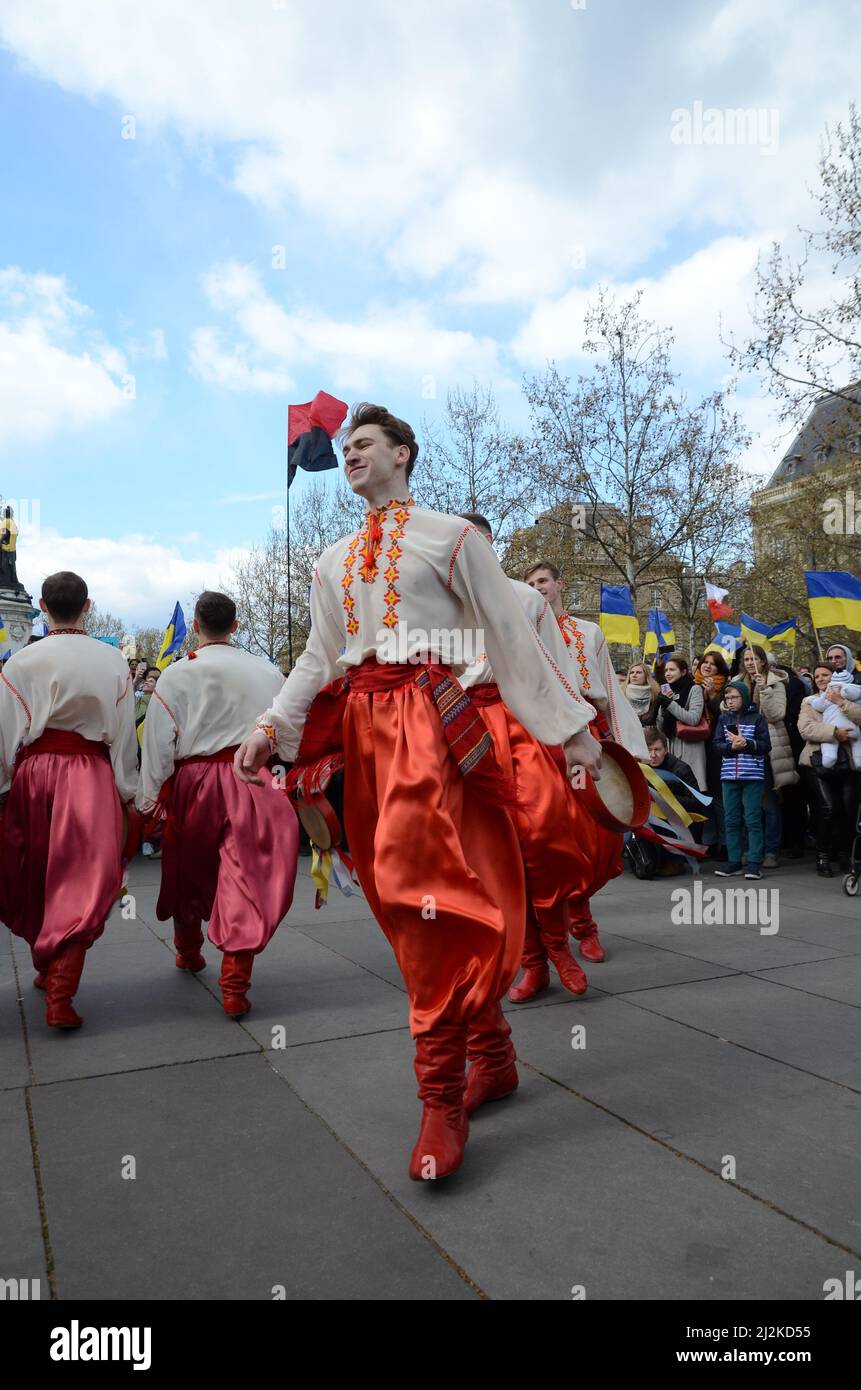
left=727, top=104, right=861, bottom=436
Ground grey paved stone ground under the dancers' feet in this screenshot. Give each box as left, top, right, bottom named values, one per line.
left=0, top=859, right=861, bottom=1300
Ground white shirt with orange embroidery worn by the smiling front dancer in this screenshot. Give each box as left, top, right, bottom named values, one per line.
left=257, top=499, right=593, bottom=760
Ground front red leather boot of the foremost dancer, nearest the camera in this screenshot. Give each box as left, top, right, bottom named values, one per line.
left=409, top=1023, right=469, bottom=1183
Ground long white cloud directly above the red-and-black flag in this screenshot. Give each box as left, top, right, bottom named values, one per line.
left=191, top=261, right=499, bottom=392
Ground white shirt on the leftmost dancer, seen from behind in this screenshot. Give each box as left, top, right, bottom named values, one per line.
left=0, top=632, right=138, bottom=802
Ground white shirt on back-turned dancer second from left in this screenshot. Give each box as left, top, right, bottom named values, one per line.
left=136, top=642, right=284, bottom=812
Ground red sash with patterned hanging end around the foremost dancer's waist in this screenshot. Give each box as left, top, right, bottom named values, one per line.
left=285, top=656, right=516, bottom=806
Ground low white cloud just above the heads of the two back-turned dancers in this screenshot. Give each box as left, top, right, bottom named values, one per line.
left=18, top=527, right=248, bottom=627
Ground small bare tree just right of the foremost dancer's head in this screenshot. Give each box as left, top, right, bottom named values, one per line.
left=413, top=381, right=534, bottom=538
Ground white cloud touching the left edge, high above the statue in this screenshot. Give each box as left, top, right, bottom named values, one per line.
left=0, top=265, right=128, bottom=446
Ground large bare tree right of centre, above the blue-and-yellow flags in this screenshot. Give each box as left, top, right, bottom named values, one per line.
left=526, top=291, right=748, bottom=612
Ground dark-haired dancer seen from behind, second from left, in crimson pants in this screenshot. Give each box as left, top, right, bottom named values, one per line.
left=138, top=589, right=299, bottom=1017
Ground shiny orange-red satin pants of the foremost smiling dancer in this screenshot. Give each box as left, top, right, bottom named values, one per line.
left=344, top=682, right=526, bottom=1037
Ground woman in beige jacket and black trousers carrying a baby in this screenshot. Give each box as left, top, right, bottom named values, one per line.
left=798, top=662, right=861, bottom=878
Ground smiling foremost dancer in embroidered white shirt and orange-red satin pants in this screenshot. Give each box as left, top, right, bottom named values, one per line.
left=235, top=406, right=601, bottom=1180
